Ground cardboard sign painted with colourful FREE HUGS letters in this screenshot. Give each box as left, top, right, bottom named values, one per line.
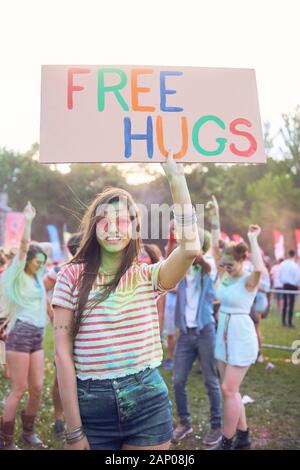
left=40, top=65, right=266, bottom=163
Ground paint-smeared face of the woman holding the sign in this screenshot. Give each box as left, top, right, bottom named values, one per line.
left=96, top=201, right=132, bottom=253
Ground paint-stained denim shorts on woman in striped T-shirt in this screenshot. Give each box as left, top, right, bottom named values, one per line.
left=77, top=368, right=173, bottom=450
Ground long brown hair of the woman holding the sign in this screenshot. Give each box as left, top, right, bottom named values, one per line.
left=69, top=187, right=141, bottom=338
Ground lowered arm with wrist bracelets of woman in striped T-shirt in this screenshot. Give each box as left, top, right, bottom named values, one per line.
left=54, top=307, right=88, bottom=449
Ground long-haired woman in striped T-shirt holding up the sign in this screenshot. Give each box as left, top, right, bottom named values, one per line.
left=52, top=153, right=200, bottom=450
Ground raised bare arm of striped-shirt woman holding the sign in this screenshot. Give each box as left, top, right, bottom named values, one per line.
left=159, top=152, right=201, bottom=289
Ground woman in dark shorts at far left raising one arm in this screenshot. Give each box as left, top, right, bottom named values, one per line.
left=0, top=202, right=47, bottom=450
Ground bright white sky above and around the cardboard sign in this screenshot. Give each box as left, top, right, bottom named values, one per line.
left=0, top=0, right=300, bottom=182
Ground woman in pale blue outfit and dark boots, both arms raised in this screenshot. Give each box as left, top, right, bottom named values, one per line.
left=208, top=197, right=265, bottom=450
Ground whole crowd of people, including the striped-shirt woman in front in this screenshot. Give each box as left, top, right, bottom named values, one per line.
left=0, top=154, right=300, bottom=450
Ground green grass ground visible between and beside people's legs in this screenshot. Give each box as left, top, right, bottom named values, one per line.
left=0, top=304, right=300, bottom=450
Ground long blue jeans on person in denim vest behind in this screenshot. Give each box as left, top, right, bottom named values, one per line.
left=173, top=323, right=222, bottom=429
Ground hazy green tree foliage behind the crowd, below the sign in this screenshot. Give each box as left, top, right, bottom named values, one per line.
left=0, top=107, right=300, bottom=254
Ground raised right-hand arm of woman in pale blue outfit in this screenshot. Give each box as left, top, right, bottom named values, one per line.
left=246, top=225, right=266, bottom=291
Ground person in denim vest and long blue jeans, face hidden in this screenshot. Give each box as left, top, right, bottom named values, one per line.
left=173, top=231, right=222, bottom=446
